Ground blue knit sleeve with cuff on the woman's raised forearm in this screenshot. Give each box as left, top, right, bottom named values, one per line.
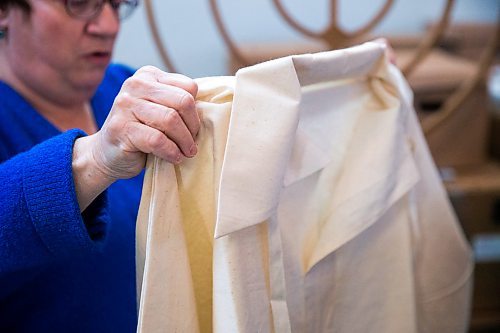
left=0, top=130, right=108, bottom=276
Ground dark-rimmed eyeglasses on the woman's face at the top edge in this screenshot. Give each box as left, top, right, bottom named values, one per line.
left=64, top=0, right=139, bottom=20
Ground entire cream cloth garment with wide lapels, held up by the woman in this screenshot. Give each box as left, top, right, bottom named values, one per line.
left=137, top=43, right=472, bottom=333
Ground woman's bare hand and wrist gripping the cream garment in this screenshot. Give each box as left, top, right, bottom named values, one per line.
left=73, top=66, right=200, bottom=211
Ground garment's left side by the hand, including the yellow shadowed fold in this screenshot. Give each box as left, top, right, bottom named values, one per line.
left=136, top=78, right=233, bottom=332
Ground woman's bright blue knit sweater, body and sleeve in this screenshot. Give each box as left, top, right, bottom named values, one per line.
left=0, top=65, right=142, bottom=332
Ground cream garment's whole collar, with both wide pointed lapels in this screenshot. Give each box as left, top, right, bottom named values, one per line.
left=215, top=43, right=418, bottom=256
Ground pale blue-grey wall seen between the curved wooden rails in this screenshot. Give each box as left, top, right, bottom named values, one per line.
left=115, top=0, right=500, bottom=77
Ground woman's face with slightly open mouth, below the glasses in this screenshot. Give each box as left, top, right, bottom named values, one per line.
left=0, top=0, right=120, bottom=103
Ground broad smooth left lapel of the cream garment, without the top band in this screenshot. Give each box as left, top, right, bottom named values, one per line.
left=215, top=58, right=300, bottom=238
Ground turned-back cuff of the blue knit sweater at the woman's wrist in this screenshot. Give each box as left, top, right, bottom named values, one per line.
left=23, top=130, right=108, bottom=256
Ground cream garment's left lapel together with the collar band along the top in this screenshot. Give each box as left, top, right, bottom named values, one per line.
left=215, top=43, right=394, bottom=238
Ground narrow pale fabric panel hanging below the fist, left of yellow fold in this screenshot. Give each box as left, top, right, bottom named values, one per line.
left=137, top=159, right=199, bottom=332
